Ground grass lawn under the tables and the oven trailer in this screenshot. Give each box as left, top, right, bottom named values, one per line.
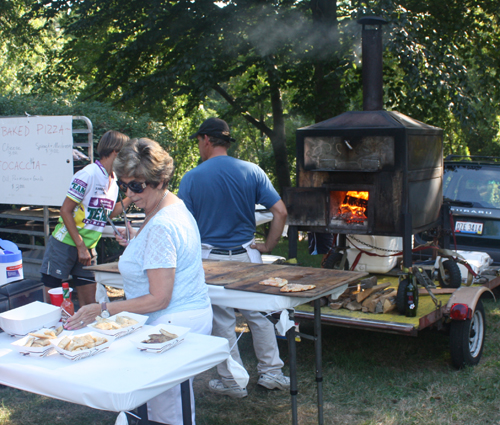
left=0, top=237, right=500, bottom=425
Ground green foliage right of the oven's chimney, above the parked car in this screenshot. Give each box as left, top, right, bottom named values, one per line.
left=379, top=0, right=500, bottom=155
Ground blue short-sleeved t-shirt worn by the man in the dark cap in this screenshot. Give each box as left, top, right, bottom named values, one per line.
left=178, top=155, right=280, bottom=249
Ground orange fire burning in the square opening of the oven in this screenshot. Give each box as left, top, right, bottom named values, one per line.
left=330, top=190, right=370, bottom=228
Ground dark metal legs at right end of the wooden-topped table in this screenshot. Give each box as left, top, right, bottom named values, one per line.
left=286, top=298, right=324, bottom=425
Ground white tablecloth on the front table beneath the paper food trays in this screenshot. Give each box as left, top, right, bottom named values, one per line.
left=0, top=333, right=229, bottom=412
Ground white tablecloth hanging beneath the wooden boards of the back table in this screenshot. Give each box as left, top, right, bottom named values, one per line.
left=95, top=271, right=348, bottom=312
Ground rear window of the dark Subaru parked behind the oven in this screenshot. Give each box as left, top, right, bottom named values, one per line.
left=443, top=164, right=500, bottom=208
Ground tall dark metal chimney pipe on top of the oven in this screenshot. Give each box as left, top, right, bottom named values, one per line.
left=358, top=16, right=387, bottom=111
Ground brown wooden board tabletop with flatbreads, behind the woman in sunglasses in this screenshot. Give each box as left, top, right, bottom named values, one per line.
left=204, top=261, right=367, bottom=298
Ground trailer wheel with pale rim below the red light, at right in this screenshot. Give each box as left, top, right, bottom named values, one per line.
left=450, top=300, right=486, bottom=369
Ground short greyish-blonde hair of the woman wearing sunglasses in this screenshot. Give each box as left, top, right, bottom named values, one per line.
left=113, top=138, right=174, bottom=189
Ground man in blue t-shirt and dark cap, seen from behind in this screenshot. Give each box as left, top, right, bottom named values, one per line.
left=178, top=118, right=290, bottom=398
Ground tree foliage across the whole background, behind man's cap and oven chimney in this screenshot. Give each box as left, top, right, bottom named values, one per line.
left=0, top=0, right=500, bottom=186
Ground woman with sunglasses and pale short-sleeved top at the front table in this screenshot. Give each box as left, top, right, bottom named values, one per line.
left=68, top=139, right=212, bottom=424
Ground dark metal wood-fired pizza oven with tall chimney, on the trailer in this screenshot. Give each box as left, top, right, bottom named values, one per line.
left=285, top=18, right=443, bottom=266
